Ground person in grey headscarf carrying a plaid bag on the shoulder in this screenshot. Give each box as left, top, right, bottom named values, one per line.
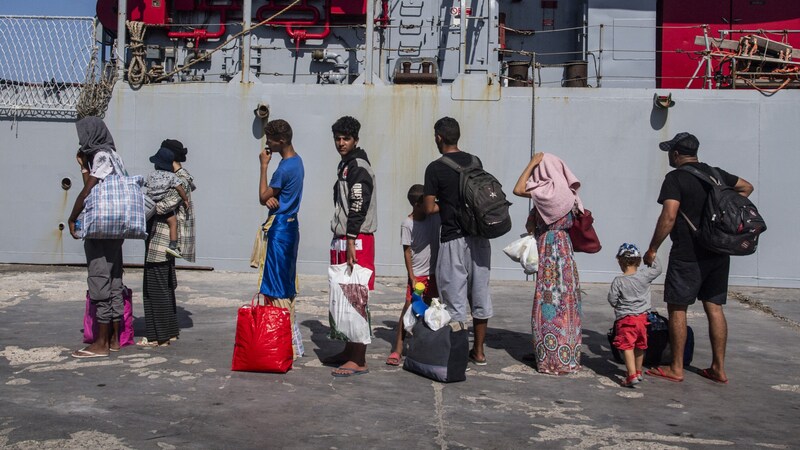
left=68, top=117, right=125, bottom=358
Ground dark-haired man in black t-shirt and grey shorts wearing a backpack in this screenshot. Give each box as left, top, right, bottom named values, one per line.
left=423, top=117, right=496, bottom=365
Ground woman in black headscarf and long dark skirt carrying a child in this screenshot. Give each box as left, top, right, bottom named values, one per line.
left=137, top=139, right=195, bottom=347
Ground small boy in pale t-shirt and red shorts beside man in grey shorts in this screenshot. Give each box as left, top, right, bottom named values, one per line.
left=386, top=184, right=441, bottom=366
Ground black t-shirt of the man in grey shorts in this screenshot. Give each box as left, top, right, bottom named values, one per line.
left=424, top=152, right=483, bottom=242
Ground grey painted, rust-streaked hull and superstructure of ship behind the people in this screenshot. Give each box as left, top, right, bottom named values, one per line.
left=0, top=0, right=800, bottom=287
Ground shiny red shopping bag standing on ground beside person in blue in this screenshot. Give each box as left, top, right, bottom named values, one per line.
left=231, top=294, right=293, bottom=373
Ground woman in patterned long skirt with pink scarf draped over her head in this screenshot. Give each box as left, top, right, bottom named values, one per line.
left=514, top=153, right=583, bottom=375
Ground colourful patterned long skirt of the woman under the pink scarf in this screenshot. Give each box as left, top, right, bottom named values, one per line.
left=531, top=213, right=581, bottom=374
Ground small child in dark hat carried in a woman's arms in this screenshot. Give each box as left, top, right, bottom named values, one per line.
left=144, top=147, right=189, bottom=258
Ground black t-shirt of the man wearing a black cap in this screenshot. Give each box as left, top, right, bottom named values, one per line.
left=658, top=162, right=739, bottom=261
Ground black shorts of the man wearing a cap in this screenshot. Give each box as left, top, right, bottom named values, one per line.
left=664, top=255, right=731, bottom=305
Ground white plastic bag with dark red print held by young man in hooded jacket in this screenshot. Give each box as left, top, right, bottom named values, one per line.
left=328, top=264, right=372, bottom=344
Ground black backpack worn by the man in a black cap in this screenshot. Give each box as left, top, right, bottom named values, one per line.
left=680, top=164, right=767, bottom=255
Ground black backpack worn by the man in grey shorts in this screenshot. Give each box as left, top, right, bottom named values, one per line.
left=439, top=155, right=511, bottom=239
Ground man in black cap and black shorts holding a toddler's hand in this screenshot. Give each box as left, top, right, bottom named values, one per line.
left=644, top=132, right=753, bottom=383
